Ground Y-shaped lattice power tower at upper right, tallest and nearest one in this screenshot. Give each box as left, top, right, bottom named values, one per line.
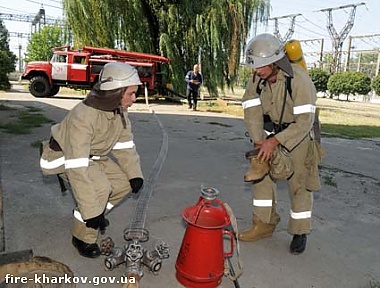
left=319, top=2, right=365, bottom=73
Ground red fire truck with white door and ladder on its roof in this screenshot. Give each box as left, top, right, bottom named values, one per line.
left=21, top=46, right=170, bottom=97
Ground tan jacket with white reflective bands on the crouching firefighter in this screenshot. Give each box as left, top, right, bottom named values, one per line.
left=51, top=102, right=143, bottom=219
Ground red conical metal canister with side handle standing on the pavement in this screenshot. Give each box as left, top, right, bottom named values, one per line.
left=175, top=188, right=234, bottom=288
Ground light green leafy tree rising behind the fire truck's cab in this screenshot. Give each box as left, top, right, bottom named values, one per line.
left=25, top=25, right=63, bottom=62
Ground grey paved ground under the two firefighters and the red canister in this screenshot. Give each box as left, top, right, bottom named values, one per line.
left=0, top=88, right=380, bottom=288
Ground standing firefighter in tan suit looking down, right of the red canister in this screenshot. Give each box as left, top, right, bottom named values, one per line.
left=238, top=34, right=321, bottom=254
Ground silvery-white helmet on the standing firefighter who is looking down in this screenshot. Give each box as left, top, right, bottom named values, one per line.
left=245, top=33, right=285, bottom=68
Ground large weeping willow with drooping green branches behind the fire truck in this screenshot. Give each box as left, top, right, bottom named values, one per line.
left=63, top=0, right=270, bottom=95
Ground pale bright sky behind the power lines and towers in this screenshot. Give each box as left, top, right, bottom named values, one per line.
left=0, top=0, right=380, bottom=69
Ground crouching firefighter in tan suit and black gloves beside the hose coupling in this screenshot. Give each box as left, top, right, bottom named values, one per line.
left=40, top=63, right=143, bottom=258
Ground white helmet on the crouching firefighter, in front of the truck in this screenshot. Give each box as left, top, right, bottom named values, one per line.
left=99, top=62, right=142, bottom=90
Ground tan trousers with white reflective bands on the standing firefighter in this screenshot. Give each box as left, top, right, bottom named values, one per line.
left=252, top=136, right=313, bottom=234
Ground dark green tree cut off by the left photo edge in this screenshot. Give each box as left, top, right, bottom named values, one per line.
left=0, top=19, right=17, bottom=90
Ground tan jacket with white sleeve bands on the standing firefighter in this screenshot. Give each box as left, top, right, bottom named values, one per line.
left=242, top=64, right=316, bottom=151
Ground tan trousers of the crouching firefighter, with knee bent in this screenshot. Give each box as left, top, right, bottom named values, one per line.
left=72, top=158, right=132, bottom=243
